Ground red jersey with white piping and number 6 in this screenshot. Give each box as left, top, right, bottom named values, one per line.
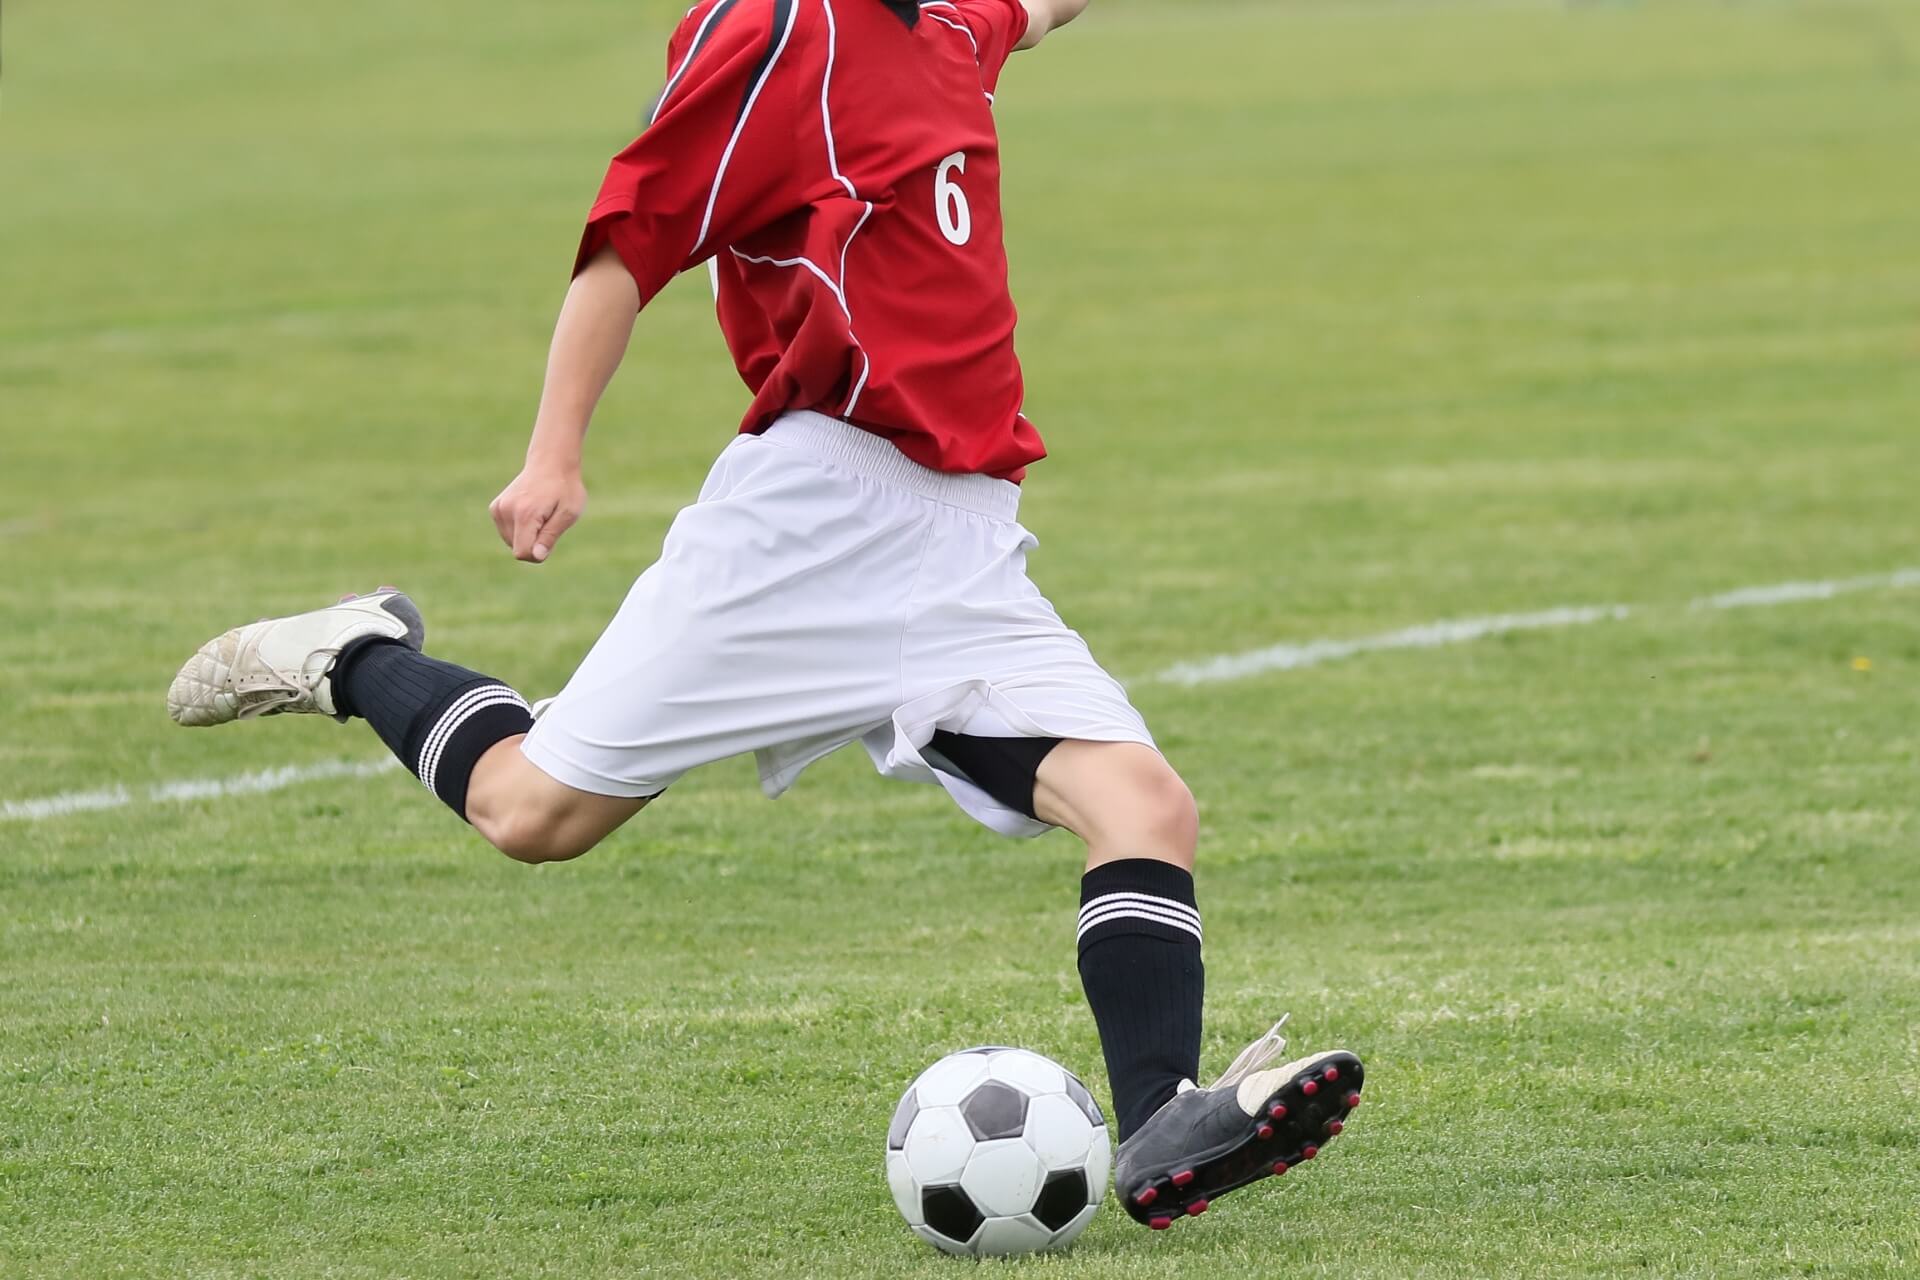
left=580, top=0, right=1046, bottom=480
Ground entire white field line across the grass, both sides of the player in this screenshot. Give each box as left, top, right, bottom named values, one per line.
left=0, top=568, right=1920, bottom=821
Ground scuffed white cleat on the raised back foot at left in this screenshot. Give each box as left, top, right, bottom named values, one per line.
left=167, top=587, right=426, bottom=727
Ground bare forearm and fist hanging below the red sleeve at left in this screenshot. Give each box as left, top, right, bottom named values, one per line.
left=488, top=248, right=639, bottom=564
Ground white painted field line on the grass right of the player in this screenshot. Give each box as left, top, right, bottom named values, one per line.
left=1154, top=568, right=1920, bottom=687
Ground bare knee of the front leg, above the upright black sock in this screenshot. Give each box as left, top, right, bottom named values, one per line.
left=1033, top=739, right=1200, bottom=867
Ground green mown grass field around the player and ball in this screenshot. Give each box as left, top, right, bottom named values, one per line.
left=0, top=0, right=1920, bottom=1280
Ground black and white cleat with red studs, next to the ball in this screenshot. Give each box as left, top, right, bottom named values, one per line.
left=1114, top=1019, right=1365, bottom=1230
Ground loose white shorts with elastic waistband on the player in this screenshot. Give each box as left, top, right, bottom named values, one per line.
left=522, top=404, right=1152, bottom=835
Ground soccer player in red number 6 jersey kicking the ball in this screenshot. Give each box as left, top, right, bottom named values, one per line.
left=167, top=0, right=1361, bottom=1226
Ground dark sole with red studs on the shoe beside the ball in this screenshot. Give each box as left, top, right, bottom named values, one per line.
left=1121, top=1052, right=1367, bottom=1230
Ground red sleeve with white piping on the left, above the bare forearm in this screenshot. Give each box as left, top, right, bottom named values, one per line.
left=574, top=0, right=806, bottom=305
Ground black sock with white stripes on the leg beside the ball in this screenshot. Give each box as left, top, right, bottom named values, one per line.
left=1079, top=858, right=1206, bottom=1142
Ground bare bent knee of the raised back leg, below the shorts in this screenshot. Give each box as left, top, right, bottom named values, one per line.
left=467, top=737, right=653, bottom=862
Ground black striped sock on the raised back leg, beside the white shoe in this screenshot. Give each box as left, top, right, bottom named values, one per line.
left=326, top=639, right=534, bottom=818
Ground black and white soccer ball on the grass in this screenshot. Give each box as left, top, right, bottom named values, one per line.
left=887, top=1046, right=1114, bottom=1257
